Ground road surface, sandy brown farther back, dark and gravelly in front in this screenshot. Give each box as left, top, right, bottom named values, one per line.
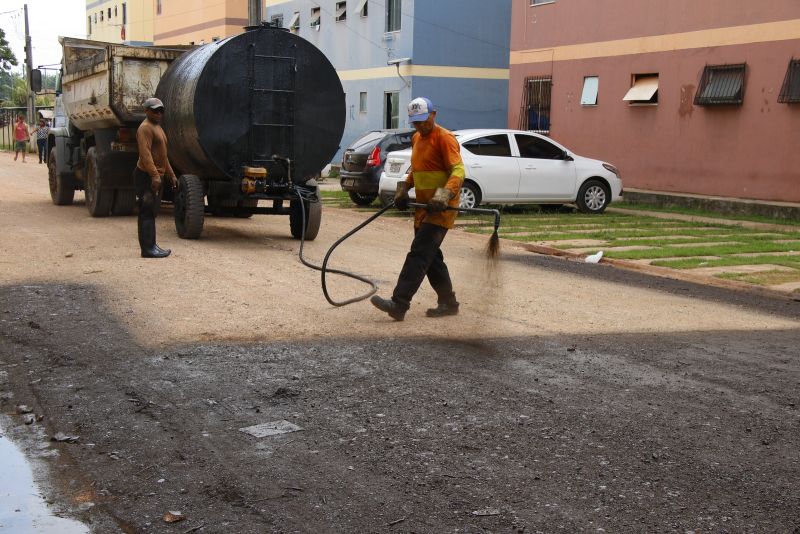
left=0, top=153, right=800, bottom=533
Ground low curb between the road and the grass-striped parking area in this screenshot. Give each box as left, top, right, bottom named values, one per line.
left=502, top=239, right=800, bottom=302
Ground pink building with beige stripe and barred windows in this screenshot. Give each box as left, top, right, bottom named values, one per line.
left=508, top=0, right=800, bottom=202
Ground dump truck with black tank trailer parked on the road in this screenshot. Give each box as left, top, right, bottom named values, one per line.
left=48, top=25, right=345, bottom=239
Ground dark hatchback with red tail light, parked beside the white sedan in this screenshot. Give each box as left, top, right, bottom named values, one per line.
left=339, top=128, right=414, bottom=206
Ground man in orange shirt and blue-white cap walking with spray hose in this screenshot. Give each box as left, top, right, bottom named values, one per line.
left=370, top=98, right=464, bottom=321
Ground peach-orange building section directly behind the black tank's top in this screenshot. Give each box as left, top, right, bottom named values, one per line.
left=153, top=0, right=248, bottom=45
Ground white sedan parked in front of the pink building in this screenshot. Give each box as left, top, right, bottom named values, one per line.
left=378, top=130, right=622, bottom=213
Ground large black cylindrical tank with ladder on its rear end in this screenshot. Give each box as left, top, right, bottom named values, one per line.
left=156, top=26, right=345, bottom=182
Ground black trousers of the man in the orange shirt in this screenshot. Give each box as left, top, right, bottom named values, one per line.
left=392, top=223, right=456, bottom=309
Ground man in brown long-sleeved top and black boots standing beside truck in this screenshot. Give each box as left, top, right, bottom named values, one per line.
left=133, top=98, right=178, bottom=258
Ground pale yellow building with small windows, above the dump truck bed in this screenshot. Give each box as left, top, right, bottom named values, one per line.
left=86, top=0, right=155, bottom=45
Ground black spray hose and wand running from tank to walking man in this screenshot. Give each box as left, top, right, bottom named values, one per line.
left=296, top=188, right=500, bottom=307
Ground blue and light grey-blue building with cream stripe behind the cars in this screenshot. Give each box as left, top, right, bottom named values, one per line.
left=264, top=0, right=511, bottom=163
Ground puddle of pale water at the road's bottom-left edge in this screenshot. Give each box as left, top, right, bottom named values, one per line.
left=0, top=421, right=89, bottom=534
